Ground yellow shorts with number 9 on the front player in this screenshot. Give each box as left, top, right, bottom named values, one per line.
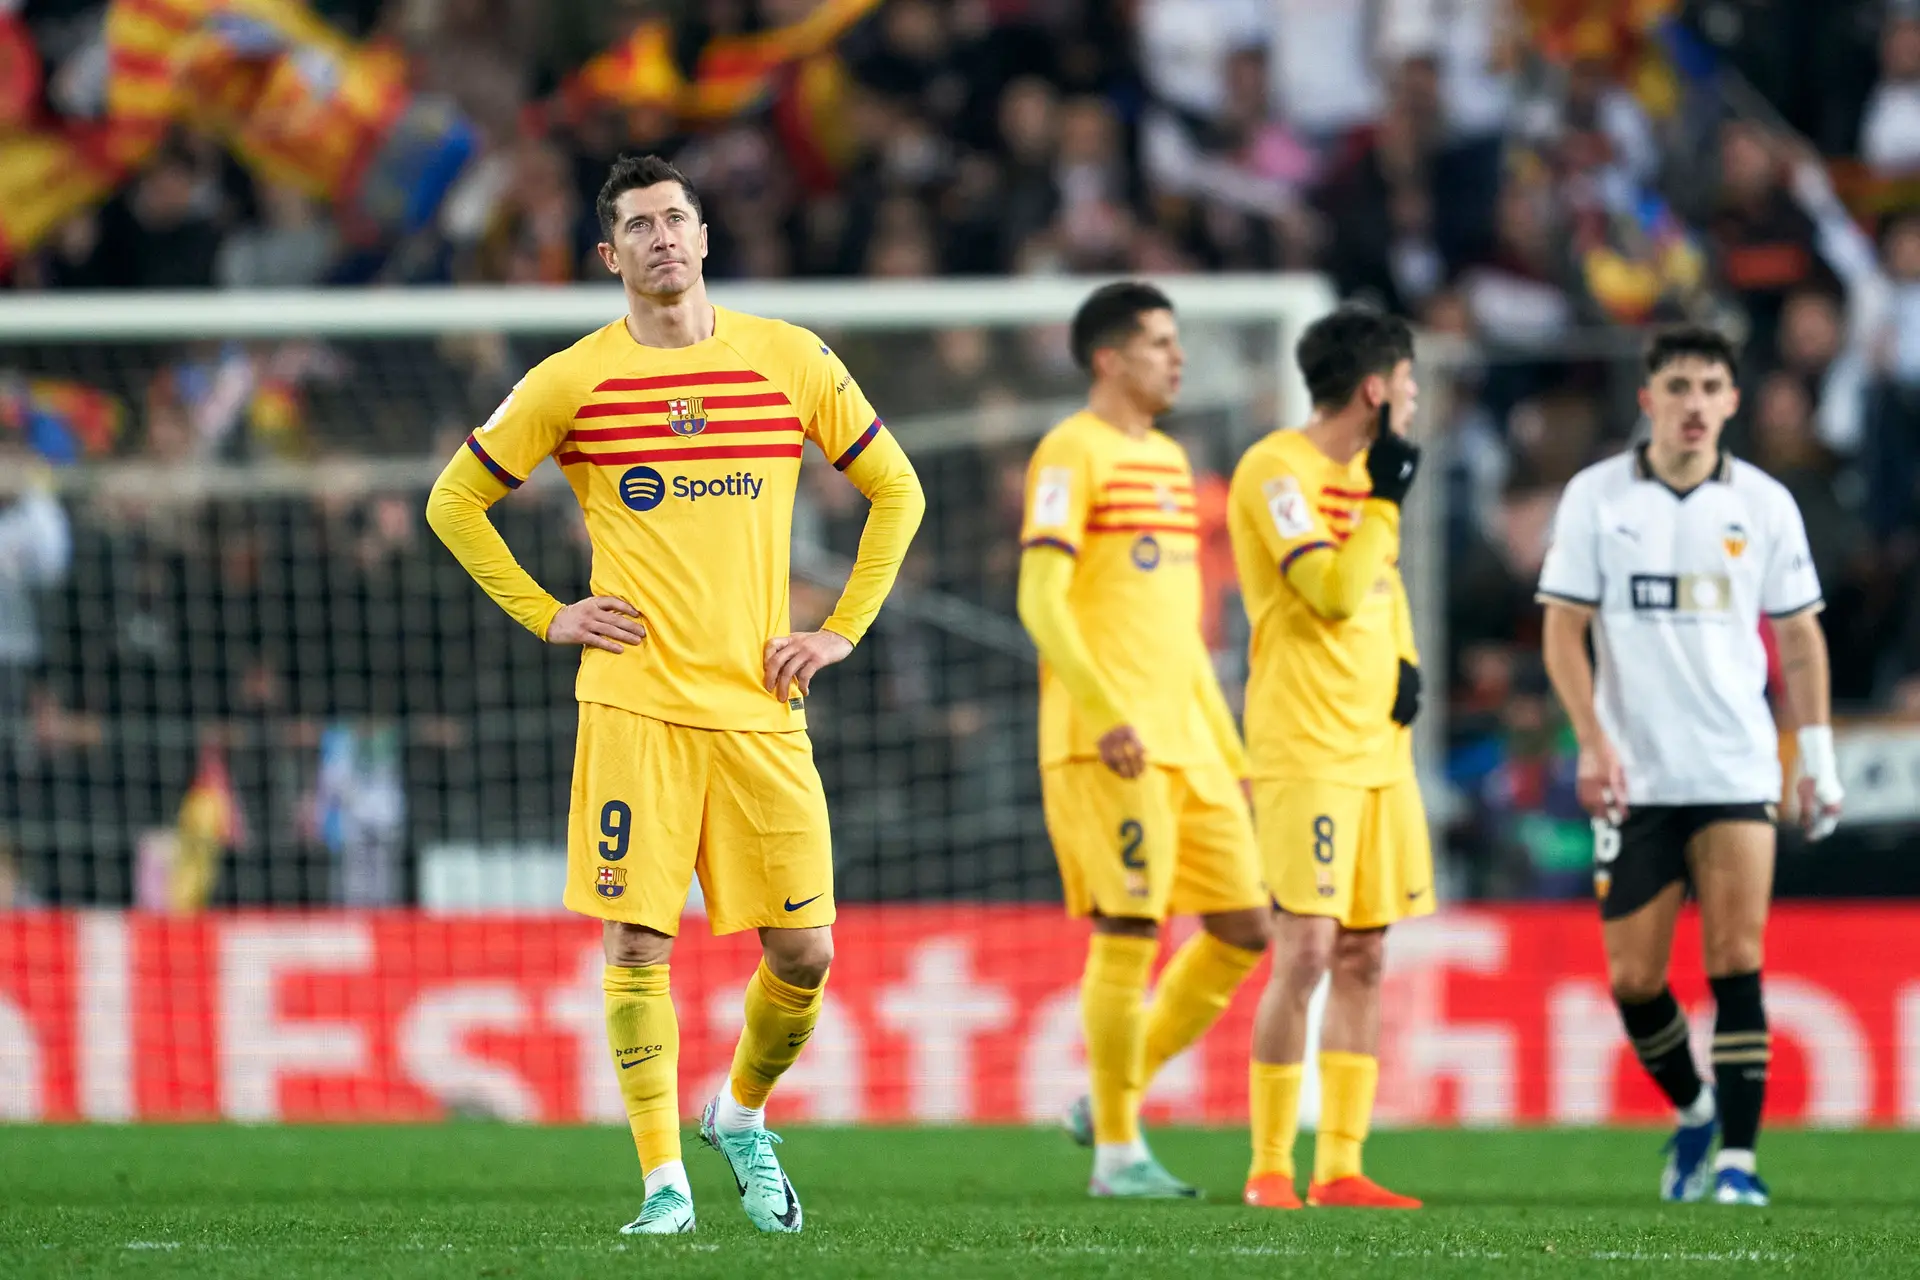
left=564, top=702, right=833, bottom=935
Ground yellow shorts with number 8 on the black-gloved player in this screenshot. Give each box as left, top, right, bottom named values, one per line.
left=1254, top=777, right=1434, bottom=929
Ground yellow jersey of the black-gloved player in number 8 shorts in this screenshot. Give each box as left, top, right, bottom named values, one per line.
left=1227, top=430, right=1419, bottom=787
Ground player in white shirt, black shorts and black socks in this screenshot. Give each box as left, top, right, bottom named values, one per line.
left=1540, top=328, right=1841, bottom=1205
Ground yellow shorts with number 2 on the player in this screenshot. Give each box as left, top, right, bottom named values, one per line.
left=1041, top=760, right=1267, bottom=919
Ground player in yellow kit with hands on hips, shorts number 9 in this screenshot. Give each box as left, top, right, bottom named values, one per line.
left=428, top=155, right=925, bottom=1234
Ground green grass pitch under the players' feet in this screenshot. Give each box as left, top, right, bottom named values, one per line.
left=0, top=1123, right=1920, bottom=1280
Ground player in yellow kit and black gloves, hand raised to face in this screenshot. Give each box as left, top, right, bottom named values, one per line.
left=1227, top=307, right=1434, bottom=1209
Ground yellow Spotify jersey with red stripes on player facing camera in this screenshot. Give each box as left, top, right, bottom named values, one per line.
left=428, top=307, right=925, bottom=731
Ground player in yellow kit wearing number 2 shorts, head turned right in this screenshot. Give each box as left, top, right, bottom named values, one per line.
left=1020, top=282, right=1267, bottom=1197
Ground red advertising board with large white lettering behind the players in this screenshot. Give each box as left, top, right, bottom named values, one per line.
left=0, top=906, right=1920, bottom=1125
